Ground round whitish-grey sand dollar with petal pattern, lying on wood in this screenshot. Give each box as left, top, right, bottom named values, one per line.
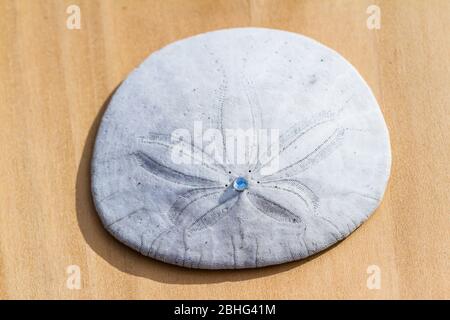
left=92, top=28, right=391, bottom=269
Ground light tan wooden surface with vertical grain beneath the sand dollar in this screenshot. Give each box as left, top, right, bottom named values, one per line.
left=0, top=0, right=450, bottom=299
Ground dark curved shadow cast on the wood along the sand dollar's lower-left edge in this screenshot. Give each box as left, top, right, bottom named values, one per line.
left=76, top=88, right=336, bottom=284
